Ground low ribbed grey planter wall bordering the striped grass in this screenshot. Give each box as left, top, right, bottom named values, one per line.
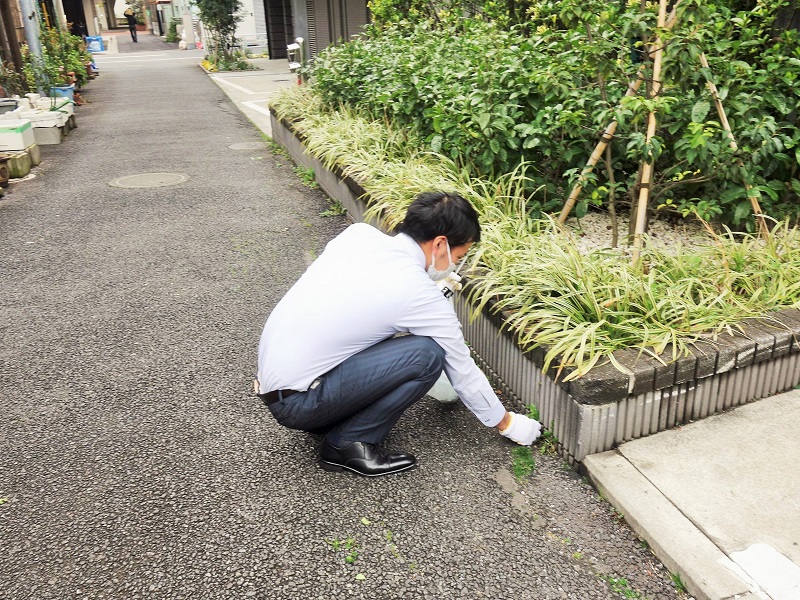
left=271, top=112, right=800, bottom=466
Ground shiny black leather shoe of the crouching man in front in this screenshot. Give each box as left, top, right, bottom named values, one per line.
left=319, top=439, right=417, bottom=477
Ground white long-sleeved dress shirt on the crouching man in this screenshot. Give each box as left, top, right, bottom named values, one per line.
left=258, top=223, right=505, bottom=426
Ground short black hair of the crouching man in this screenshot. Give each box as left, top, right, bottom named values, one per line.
left=397, top=192, right=481, bottom=248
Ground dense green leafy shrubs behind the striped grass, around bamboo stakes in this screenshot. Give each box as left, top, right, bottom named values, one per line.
left=311, top=0, right=800, bottom=230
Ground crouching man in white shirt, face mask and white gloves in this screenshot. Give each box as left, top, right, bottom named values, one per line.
left=256, top=192, right=542, bottom=477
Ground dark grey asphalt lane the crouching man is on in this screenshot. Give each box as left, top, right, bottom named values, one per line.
left=0, top=43, right=679, bottom=600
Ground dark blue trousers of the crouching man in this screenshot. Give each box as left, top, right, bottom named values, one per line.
left=269, top=335, right=444, bottom=444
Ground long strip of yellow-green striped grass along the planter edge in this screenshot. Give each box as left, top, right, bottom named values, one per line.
left=275, top=86, right=800, bottom=380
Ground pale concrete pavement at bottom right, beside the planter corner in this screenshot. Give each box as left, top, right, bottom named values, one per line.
left=584, top=390, right=800, bottom=600
